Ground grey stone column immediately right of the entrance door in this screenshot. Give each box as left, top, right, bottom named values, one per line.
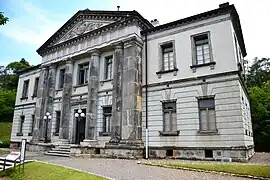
left=83, top=51, right=100, bottom=145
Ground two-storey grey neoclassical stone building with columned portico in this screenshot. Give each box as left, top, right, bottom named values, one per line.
left=11, top=3, right=254, bottom=160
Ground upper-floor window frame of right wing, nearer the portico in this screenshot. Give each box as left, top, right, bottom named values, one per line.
left=156, top=40, right=178, bottom=75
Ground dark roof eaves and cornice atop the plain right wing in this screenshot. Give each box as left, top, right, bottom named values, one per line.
left=141, top=3, right=247, bottom=56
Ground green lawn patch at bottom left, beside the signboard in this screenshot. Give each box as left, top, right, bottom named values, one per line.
left=0, top=162, right=106, bottom=180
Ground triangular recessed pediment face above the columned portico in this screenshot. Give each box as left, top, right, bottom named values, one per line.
left=54, top=19, right=114, bottom=45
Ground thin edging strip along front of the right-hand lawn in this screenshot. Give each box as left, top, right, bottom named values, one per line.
left=143, top=162, right=270, bottom=180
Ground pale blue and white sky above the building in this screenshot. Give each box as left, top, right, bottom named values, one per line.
left=0, top=0, right=270, bottom=66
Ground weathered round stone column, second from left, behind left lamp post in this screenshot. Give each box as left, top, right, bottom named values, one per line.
left=44, top=64, right=56, bottom=139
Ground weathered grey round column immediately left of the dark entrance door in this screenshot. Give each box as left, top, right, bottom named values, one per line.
left=59, top=58, right=74, bottom=143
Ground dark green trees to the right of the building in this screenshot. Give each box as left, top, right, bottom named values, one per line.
left=247, top=58, right=270, bottom=152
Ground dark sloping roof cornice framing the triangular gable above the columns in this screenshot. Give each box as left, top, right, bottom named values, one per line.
left=37, top=9, right=153, bottom=54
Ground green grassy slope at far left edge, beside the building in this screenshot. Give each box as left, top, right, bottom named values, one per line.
left=0, top=122, right=12, bottom=148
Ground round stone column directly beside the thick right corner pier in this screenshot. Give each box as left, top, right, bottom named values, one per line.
left=110, top=44, right=124, bottom=143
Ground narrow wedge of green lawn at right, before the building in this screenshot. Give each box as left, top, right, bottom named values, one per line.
left=145, top=162, right=270, bottom=178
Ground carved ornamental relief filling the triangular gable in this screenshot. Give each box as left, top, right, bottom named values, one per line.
left=56, top=21, right=108, bottom=44
